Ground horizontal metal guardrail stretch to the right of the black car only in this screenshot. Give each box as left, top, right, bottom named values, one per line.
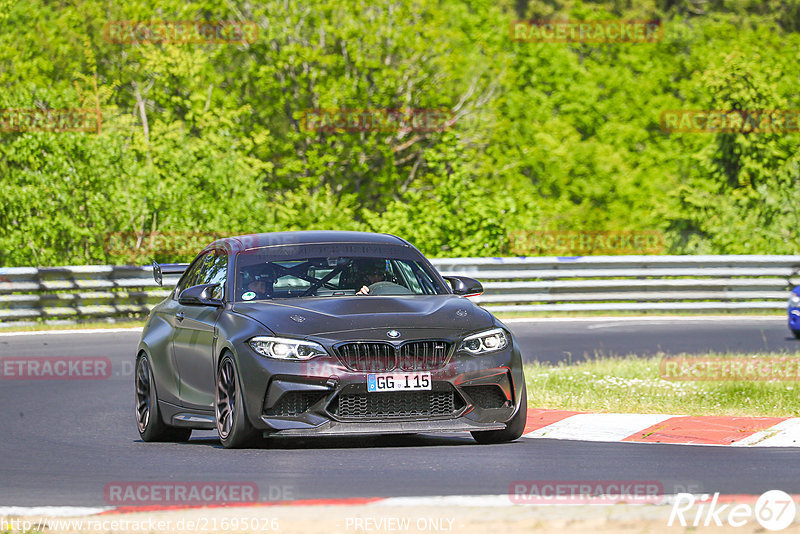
left=434, top=255, right=800, bottom=312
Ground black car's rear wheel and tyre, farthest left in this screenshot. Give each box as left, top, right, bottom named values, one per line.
left=134, top=354, right=192, bottom=441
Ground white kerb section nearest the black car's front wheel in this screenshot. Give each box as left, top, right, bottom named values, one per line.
left=523, top=413, right=675, bottom=441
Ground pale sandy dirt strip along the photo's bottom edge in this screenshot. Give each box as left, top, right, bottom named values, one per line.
left=6, top=501, right=800, bottom=534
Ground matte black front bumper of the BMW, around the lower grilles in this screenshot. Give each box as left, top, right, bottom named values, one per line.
left=234, top=343, right=524, bottom=436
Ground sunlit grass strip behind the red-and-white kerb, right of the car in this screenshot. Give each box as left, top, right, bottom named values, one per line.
left=525, top=352, right=800, bottom=417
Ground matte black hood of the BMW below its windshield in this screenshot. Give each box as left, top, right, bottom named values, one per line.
left=228, top=295, right=495, bottom=336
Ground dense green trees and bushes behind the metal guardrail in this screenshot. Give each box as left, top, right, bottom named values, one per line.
left=0, top=0, right=800, bottom=266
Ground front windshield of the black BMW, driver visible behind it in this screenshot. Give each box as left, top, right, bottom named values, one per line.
left=235, top=253, right=447, bottom=301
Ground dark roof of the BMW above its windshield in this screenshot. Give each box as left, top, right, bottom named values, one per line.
left=206, top=230, right=413, bottom=252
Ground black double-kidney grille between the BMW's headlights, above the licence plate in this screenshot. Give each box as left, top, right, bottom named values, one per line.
left=336, top=341, right=452, bottom=372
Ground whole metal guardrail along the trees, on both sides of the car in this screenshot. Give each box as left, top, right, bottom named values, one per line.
left=0, top=256, right=800, bottom=325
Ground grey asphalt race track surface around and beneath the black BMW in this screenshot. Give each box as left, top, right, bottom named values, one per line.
left=0, top=318, right=800, bottom=506
